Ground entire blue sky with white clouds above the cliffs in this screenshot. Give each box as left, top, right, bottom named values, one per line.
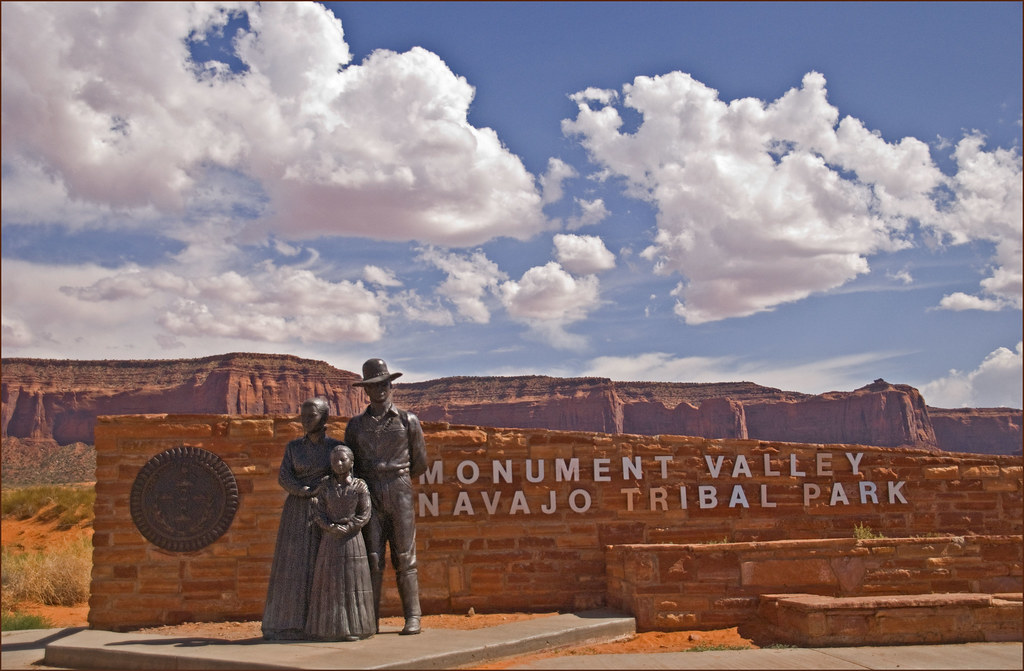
left=2, top=2, right=1024, bottom=408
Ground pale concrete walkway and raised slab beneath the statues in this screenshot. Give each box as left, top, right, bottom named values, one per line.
left=0, top=611, right=1022, bottom=671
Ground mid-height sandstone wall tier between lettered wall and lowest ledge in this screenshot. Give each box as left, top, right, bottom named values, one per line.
left=607, top=536, right=1024, bottom=631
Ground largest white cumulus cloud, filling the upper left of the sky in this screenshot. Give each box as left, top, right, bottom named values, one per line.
left=2, top=2, right=548, bottom=246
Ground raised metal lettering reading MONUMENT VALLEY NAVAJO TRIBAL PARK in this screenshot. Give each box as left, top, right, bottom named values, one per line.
left=411, top=452, right=907, bottom=517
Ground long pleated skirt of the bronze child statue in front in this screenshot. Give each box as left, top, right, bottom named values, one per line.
left=306, top=530, right=377, bottom=640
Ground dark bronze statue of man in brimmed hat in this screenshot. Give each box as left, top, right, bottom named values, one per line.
left=345, top=359, right=427, bottom=634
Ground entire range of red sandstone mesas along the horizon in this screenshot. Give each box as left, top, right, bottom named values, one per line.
left=0, top=353, right=1022, bottom=454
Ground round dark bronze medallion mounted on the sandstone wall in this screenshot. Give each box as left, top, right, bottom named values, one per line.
left=131, top=447, right=239, bottom=552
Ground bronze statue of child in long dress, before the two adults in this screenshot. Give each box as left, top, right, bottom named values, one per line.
left=306, top=445, right=377, bottom=641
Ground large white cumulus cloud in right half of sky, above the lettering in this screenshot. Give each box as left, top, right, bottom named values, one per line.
left=562, top=72, right=1020, bottom=324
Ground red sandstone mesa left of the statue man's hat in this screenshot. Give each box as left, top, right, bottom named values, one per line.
left=0, top=353, right=364, bottom=445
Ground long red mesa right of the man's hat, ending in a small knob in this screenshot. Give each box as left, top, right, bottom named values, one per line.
left=397, top=376, right=938, bottom=450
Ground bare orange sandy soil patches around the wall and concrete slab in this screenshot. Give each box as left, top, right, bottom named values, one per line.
left=0, top=518, right=758, bottom=669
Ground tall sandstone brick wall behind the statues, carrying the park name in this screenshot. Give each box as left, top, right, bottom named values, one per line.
left=89, top=415, right=1022, bottom=629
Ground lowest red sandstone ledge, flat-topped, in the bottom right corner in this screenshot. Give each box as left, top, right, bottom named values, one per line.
left=758, top=593, right=1024, bottom=646
